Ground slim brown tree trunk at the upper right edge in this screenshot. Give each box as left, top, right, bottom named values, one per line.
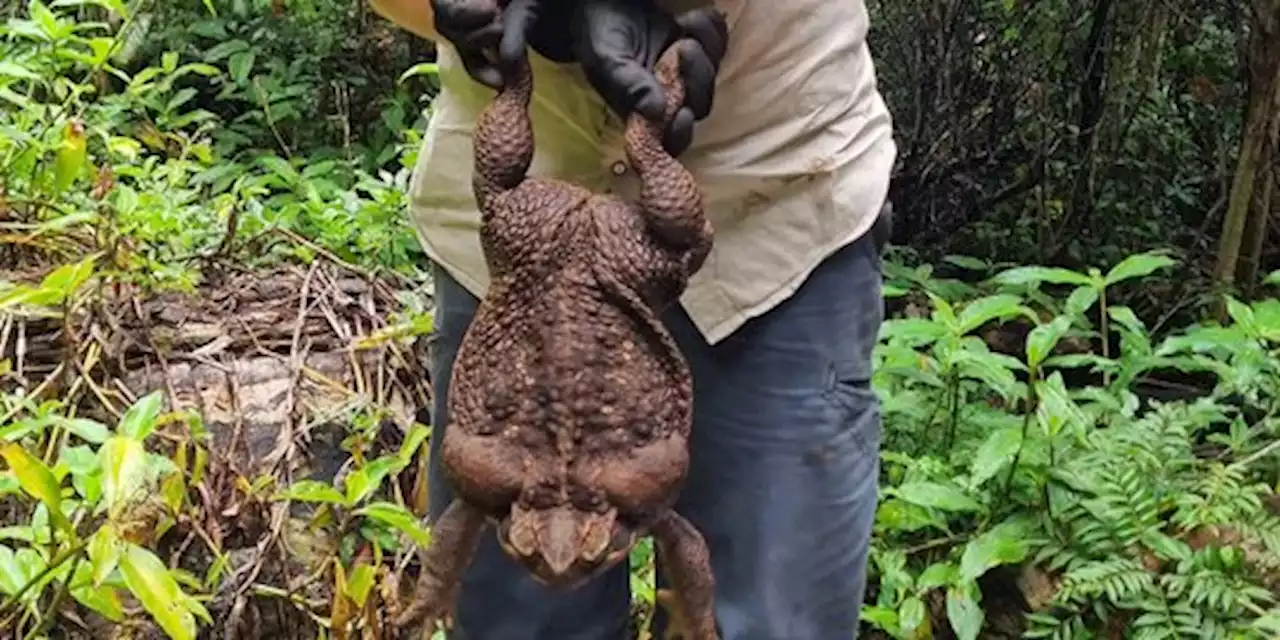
left=1213, top=0, right=1280, bottom=307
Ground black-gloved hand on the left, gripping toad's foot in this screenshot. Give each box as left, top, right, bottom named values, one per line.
left=431, top=0, right=580, bottom=90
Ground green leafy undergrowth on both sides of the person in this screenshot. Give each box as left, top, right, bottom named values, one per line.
left=0, top=0, right=1280, bottom=640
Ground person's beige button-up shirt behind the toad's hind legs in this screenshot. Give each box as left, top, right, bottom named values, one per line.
left=410, top=0, right=897, bottom=343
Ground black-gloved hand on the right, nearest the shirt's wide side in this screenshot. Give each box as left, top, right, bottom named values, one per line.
left=572, top=0, right=728, bottom=156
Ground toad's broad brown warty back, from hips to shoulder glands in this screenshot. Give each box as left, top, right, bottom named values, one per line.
left=453, top=180, right=691, bottom=452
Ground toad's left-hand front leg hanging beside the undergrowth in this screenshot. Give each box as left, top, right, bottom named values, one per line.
left=392, top=500, right=485, bottom=630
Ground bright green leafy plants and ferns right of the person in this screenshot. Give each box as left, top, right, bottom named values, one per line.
left=864, top=253, right=1280, bottom=639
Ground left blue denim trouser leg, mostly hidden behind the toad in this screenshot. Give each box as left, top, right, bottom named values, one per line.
left=428, top=266, right=631, bottom=640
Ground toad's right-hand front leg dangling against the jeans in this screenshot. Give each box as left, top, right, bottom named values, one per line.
left=653, top=511, right=718, bottom=640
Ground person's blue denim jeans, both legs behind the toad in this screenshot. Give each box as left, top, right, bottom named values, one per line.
left=429, top=227, right=883, bottom=640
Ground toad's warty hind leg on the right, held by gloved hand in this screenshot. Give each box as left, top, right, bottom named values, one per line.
left=626, top=40, right=713, bottom=276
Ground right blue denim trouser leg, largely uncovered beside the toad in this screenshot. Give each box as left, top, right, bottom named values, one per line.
left=658, top=234, right=883, bottom=640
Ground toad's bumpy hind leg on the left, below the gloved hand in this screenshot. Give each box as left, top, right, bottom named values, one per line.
left=471, top=53, right=534, bottom=215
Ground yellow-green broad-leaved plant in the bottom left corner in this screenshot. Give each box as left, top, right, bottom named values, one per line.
left=0, top=393, right=212, bottom=639
